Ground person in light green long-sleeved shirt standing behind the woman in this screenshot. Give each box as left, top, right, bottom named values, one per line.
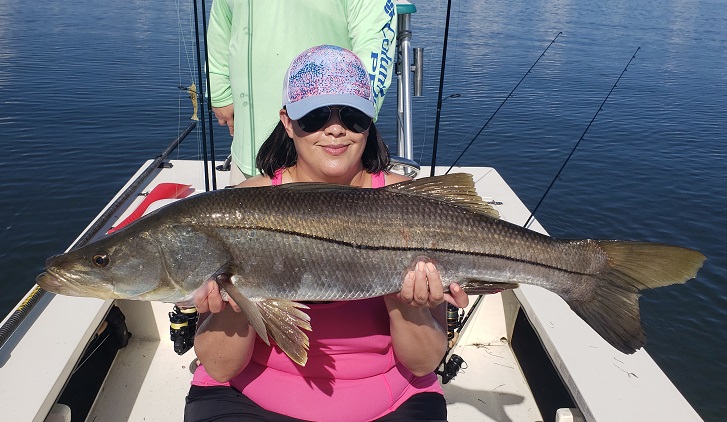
left=207, top=0, right=397, bottom=185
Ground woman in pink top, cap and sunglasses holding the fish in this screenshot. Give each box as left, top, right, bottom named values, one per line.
left=185, top=46, right=467, bottom=421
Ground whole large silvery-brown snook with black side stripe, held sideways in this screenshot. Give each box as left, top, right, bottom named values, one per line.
left=37, top=174, right=705, bottom=365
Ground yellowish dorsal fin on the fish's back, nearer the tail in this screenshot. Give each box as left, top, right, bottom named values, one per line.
left=384, top=173, right=500, bottom=218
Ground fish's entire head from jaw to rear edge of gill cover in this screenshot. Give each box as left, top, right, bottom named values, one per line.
left=36, top=221, right=231, bottom=302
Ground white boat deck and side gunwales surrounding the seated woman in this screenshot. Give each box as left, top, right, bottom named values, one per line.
left=0, top=161, right=701, bottom=422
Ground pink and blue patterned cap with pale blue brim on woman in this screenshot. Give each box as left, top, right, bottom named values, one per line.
left=283, top=45, right=375, bottom=120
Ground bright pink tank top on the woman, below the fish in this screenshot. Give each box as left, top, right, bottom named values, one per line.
left=192, top=297, right=443, bottom=421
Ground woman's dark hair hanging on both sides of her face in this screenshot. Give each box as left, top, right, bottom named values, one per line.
left=255, top=122, right=390, bottom=178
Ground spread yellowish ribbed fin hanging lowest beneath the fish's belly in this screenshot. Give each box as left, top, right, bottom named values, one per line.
left=255, top=299, right=311, bottom=366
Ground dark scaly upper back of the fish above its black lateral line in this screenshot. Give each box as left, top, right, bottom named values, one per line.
left=172, top=183, right=592, bottom=271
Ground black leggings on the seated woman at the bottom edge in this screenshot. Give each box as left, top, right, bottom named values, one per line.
left=184, top=385, right=447, bottom=422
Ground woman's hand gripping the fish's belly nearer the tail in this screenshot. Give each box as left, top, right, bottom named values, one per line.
left=398, top=261, right=469, bottom=308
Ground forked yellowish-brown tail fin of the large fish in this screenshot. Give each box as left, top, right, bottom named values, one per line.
left=564, top=241, right=706, bottom=354
